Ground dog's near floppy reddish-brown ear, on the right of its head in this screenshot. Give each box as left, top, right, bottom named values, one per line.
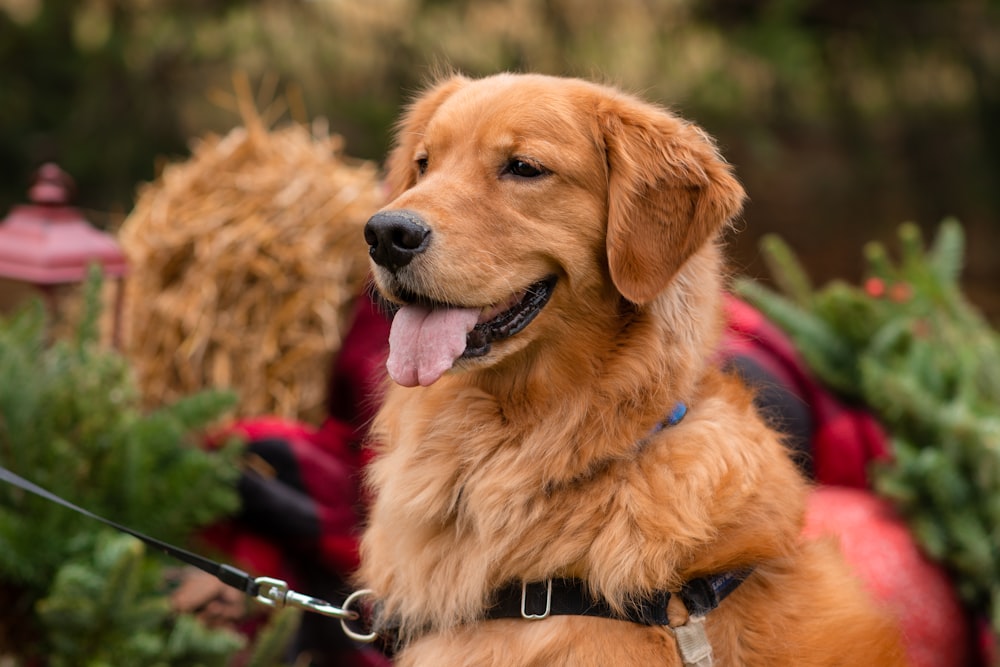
left=599, top=96, right=745, bottom=304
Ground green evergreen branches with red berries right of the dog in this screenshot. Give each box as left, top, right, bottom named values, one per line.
left=736, top=220, right=1000, bottom=631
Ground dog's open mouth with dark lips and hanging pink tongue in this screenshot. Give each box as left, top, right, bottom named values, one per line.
left=378, top=276, right=556, bottom=387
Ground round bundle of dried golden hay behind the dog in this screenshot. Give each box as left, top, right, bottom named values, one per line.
left=120, top=94, right=381, bottom=422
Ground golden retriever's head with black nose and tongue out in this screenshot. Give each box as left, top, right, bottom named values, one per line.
left=365, top=74, right=744, bottom=386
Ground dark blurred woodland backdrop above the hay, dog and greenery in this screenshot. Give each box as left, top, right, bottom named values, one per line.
left=0, top=0, right=1000, bottom=322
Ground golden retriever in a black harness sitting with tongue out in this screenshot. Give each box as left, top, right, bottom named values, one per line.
left=359, top=74, right=903, bottom=667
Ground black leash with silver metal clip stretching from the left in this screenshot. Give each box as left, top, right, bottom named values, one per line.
left=0, top=466, right=374, bottom=641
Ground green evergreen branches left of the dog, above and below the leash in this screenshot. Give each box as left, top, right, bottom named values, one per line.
left=0, top=272, right=252, bottom=666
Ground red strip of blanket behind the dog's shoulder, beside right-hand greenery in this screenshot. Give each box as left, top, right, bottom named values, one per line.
left=723, top=297, right=889, bottom=489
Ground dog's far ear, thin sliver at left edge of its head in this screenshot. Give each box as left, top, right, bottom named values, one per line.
left=385, top=74, right=468, bottom=199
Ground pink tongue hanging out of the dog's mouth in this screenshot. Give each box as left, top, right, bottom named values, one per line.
left=385, top=306, right=479, bottom=387
